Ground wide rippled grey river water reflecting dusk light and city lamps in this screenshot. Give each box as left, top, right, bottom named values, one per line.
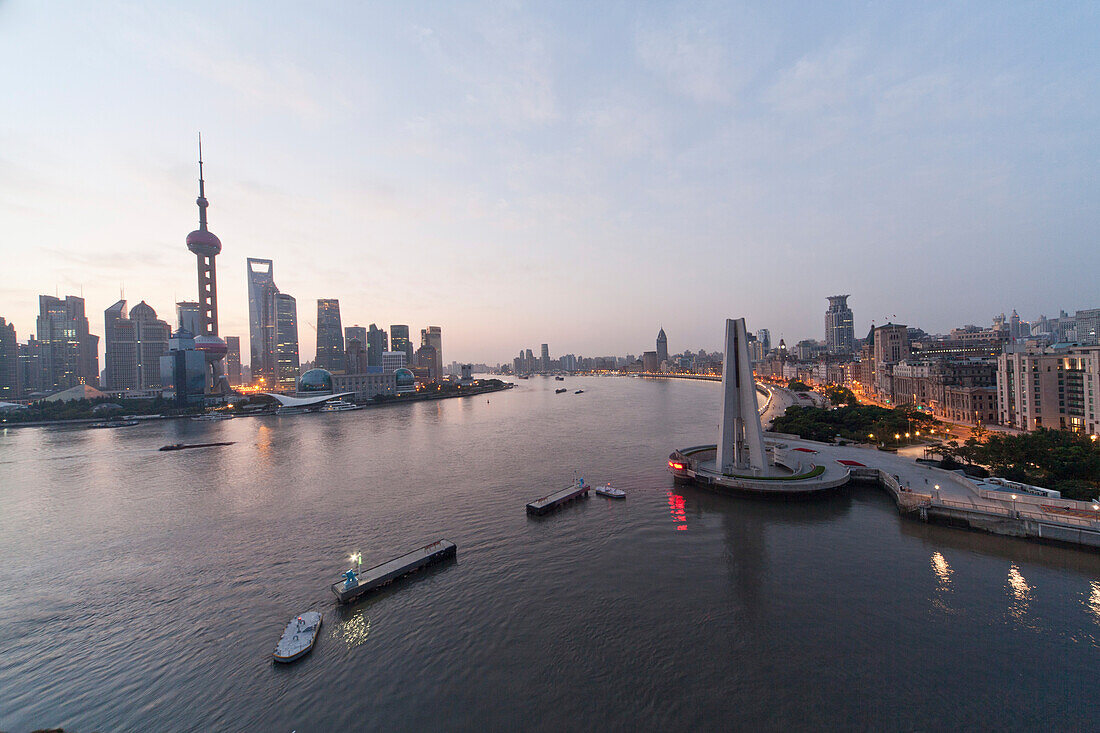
left=0, top=378, right=1100, bottom=733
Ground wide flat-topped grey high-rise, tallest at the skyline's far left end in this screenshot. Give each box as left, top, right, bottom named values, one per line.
left=36, top=295, right=99, bottom=392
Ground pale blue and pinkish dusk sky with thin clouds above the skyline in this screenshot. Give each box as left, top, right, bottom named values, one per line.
left=0, top=0, right=1100, bottom=363
